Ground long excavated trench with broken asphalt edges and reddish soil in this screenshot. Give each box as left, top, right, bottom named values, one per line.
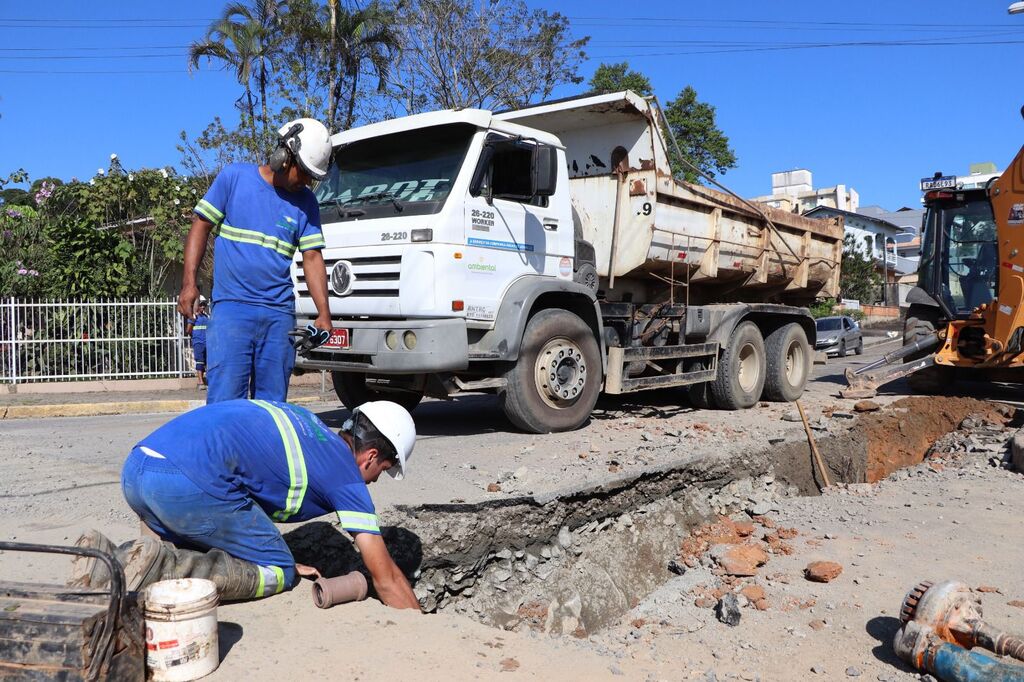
left=288, top=397, right=1012, bottom=636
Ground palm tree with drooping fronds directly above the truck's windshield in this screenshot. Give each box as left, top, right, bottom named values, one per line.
left=312, top=0, right=401, bottom=129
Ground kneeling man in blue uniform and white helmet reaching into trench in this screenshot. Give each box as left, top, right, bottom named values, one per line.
left=71, top=400, right=419, bottom=608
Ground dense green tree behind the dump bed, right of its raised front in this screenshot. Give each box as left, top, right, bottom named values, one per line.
left=665, top=85, right=736, bottom=182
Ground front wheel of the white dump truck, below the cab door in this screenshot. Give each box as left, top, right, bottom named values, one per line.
left=499, top=308, right=601, bottom=433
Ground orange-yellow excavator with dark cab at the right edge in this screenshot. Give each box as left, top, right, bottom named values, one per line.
left=842, top=143, right=1024, bottom=398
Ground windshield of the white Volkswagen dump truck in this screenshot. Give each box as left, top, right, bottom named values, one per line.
left=315, top=124, right=476, bottom=220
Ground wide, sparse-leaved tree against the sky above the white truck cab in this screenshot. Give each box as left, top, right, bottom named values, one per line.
left=392, top=0, right=589, bottom=114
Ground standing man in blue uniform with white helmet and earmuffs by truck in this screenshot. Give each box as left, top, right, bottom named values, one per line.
left=178, top=119, right=331, bottom=403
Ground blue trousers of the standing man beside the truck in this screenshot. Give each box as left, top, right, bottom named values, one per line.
left=206, top=301, right=295, bottom=404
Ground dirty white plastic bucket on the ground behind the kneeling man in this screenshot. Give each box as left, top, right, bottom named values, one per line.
left=144, top=578, right=220, bottom=682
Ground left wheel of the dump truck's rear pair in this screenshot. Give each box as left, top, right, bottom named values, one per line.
left=711, top=322, right=765, bottom=410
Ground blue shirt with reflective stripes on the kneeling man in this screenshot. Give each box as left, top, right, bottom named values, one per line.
left=137, top=400, right=380, bottom=535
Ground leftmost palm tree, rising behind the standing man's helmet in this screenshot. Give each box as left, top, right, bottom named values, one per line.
left=188, top=0, right=284, bottom=150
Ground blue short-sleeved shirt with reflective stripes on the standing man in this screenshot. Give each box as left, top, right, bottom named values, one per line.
left=195, top=164, right=324, bottom=312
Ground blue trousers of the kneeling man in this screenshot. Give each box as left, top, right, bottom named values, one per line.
left=121, top=447, right=297, bottom=596
